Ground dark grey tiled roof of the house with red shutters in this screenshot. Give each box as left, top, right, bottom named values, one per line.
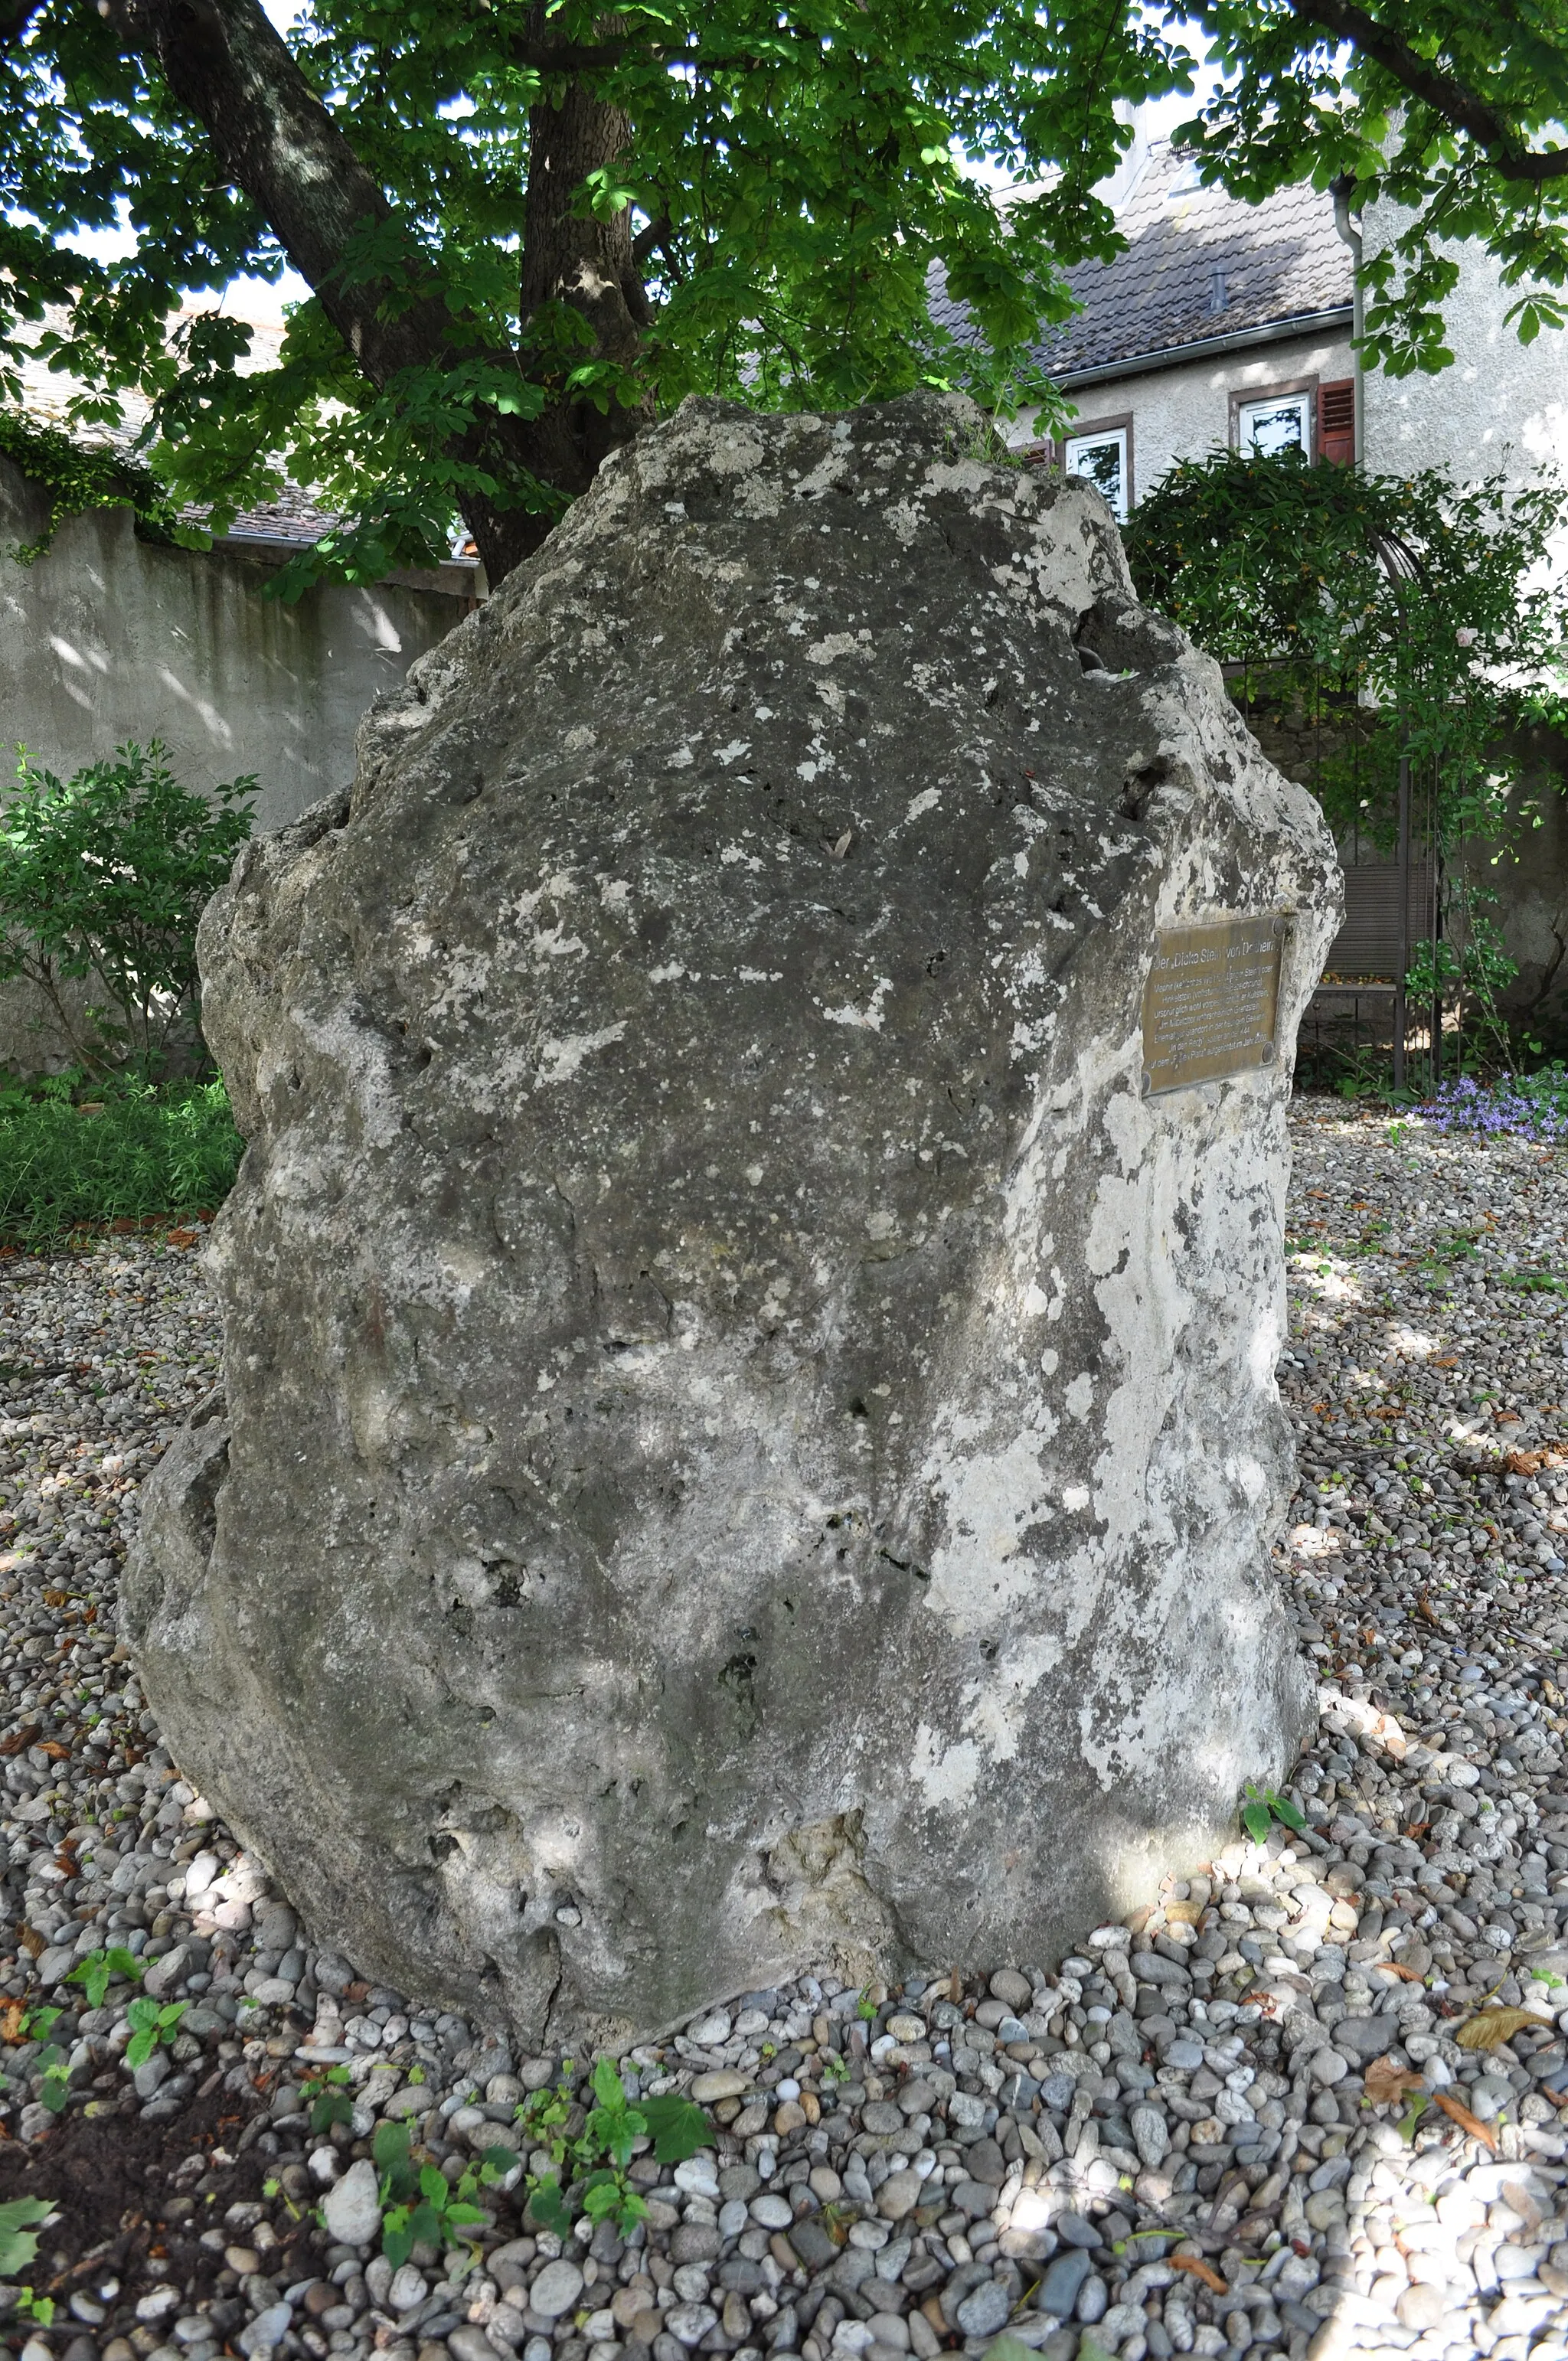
left=930, top=139, right=1351, bottom=377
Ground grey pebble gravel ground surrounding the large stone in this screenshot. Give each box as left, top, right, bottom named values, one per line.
left=0, top=1100, right=1568, bottom=2361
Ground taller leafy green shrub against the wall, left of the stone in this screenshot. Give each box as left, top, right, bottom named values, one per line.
left=0, top=739, right=255, bottom=1079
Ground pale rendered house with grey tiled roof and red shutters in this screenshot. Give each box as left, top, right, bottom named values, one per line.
left=933, top=132, right=1568, bottom=1034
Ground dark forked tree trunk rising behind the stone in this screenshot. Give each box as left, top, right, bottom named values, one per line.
left=111, top=0, right=647, bottom=586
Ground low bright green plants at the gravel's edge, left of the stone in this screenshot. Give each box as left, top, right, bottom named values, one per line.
left=0, top=1074, right=243, bottom=1249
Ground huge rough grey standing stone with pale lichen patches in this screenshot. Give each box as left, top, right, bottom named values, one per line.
left=128, top=397, right=1339, bottom=2040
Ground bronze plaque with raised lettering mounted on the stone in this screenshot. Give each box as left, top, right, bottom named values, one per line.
left=1143, top=911, right=1285, bottom=1098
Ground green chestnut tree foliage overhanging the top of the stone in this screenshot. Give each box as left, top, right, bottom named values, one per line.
left=0, top=0, right=1568, bottom=588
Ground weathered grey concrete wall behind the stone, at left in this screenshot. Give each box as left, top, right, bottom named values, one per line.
left=0, top=458, right=472, bottom=828
